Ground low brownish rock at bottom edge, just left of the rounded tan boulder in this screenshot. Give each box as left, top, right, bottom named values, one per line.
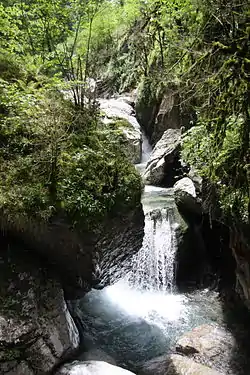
left=139, top=354, right=225, bottom=375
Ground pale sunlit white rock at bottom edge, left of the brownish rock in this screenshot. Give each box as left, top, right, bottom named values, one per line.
left=56, top=361, right=137, bottom=375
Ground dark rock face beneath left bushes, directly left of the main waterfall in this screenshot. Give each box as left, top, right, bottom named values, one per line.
left=2, top=205, right=144, bottom=300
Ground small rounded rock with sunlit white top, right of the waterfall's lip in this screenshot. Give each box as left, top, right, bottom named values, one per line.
left=174, top=177, right=202, bottom=216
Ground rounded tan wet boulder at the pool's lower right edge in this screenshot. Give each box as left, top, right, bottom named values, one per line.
left=176, top=324, right=237, bottom=375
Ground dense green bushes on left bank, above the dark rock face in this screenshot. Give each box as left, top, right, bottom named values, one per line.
left=0, top=81, right=141, bottom=225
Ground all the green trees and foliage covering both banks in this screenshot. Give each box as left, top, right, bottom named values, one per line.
left=0, top=0, right=250, bottom=226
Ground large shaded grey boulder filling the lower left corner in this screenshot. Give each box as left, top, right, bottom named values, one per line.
left=0, top=238, right=79, bottom=375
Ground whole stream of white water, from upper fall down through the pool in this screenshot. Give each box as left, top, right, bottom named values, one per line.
left=72, top=107, right=225, bottom=372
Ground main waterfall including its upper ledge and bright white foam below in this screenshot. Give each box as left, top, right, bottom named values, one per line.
left=103, top=186, right=187, bottom=332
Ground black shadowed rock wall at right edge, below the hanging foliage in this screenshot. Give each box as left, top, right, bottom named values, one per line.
left=202, top=180, right=250, bottom=310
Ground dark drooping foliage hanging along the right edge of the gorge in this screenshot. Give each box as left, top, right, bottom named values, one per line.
left=180, top=1, right=250, bottom=223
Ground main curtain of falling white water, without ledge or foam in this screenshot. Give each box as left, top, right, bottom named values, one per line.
left=126, top=208, right=176, bottom=292
